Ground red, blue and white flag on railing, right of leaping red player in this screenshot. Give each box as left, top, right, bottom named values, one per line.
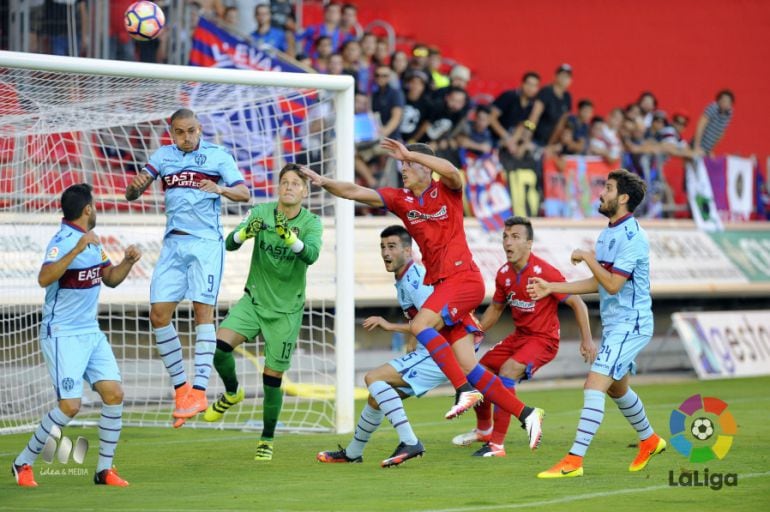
left=463, top=152, right=513, bottom=231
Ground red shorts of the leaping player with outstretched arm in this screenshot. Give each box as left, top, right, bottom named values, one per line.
left=422, top=270, right=485, bottom=326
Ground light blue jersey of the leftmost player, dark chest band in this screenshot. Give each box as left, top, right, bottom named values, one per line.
left=40, top=220, right=112, bottom=337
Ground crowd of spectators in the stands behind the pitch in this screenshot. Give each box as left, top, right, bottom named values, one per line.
left=1, top=0, right=735, bottom=217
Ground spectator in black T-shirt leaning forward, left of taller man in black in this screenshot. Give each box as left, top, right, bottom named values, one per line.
left=489, top=71, right=540, bottom=158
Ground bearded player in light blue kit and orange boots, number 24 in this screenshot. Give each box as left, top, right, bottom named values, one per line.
left=527, top=169, right=666, bottom=478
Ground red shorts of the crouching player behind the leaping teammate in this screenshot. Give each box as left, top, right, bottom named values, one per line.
left=479, top=332, right=559, bottom=380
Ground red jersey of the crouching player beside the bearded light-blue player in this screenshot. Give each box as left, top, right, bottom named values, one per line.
left=492, top=253, right=569, bottom=340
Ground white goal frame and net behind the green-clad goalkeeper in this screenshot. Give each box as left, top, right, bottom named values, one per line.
left=0, top=52, right=353, bottom=433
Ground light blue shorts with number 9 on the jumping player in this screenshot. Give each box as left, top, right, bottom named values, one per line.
left=150, top=234, right=225, bottom=306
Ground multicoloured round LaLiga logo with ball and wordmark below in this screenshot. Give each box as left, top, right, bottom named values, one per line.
left=668, top=395, right=738, bottom=490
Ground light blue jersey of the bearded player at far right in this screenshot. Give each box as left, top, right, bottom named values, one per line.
left=596, top=214, right=653, bottom=336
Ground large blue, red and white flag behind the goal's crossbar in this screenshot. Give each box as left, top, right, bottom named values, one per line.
left=186, top=17, right=310, bottom=196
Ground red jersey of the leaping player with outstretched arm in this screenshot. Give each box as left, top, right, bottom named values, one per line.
left=377, top=181, right=479, bottom=285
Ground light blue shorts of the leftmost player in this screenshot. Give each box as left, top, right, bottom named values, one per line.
left=40, top=332, right=120, bottom=400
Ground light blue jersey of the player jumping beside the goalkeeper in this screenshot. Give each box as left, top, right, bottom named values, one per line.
left=144, top=140, right=244, bottom=240
